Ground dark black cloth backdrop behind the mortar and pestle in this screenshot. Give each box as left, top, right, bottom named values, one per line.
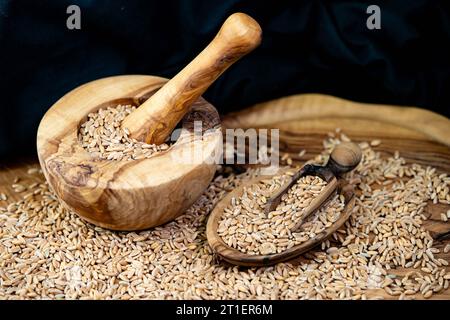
left=0, top=0, right=450, bottom=158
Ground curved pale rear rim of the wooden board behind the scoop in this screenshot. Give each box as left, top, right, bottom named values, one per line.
left=222, top=94, right=450, bottom=146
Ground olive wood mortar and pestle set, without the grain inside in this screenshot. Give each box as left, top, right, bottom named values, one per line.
left=37, top=13, right=261, bottom=230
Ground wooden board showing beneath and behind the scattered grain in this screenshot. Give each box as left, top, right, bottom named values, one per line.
left=0, top=94, right=450, bottom=299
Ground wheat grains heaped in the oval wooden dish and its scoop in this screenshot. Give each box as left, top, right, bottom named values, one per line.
left=217, top=174, right=344, bottom=255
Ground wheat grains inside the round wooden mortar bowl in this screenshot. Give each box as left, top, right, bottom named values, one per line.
left=78, top=105, right=169, bottom=161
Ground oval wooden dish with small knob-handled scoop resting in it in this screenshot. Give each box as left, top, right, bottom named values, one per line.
left=206, top=142, right=362, bottom=266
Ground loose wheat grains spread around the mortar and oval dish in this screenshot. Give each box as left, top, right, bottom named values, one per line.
left=0, top=131, right=450, bottom=299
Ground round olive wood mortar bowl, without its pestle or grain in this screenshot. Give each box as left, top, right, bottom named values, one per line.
left=37, top=76, right=222, bottom=230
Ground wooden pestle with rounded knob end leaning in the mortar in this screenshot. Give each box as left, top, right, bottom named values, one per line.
left=122, top=13, right=262, bottom=144
